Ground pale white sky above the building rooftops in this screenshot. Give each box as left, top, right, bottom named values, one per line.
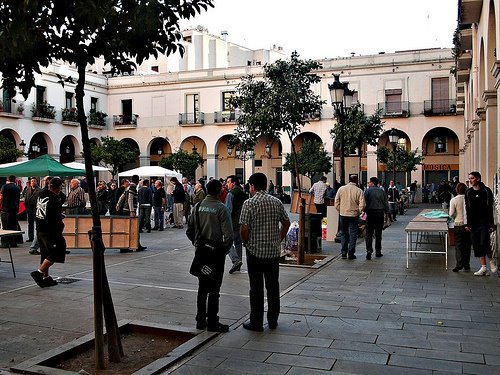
left=180, top=0, right=458, bottom=59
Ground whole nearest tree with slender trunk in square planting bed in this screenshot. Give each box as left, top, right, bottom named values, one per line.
left=0, top=0, right=213, bottom=369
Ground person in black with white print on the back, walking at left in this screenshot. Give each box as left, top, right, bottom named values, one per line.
left=31, top=177, right=66, bottom=288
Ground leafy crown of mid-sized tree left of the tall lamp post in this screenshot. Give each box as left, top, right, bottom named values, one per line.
left=231, top=52, right=324, bottom=192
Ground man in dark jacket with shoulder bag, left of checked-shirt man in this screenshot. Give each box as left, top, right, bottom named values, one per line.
left=186, top=179, right=233, bottom=332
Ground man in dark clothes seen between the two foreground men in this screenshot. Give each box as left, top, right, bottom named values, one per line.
left=225, top=175, right=246, bottom=274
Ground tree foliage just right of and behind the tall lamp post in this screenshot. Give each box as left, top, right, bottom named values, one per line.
left=330, top=103, right=384, bottom=156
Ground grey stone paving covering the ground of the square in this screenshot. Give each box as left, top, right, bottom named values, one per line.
left=0, top=206, right=500, bottom=375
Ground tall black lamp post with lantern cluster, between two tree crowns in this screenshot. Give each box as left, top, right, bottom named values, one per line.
left=328, top=74, right=354, bottom=185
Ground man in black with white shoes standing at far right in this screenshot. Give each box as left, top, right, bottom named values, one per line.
left=465, top=172, right=497, bottom=276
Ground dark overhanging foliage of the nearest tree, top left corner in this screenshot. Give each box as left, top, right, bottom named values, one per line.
left=0, top=0, right=213, bottom=100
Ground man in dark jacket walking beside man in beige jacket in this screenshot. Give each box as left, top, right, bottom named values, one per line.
left=365, top=177, right=389, bottom=260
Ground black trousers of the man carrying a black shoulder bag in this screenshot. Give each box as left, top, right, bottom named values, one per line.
left=196, top=255, right=226, bottom=327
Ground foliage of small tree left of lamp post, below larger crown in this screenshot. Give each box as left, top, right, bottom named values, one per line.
left=283, top=141, right=332, bottom=183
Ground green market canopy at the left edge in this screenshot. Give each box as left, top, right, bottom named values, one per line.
left=0, top=155, right=85, bottom=177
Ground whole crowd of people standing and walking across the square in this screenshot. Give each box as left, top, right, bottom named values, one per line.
left=0, top=172, right=497, bottom=332
